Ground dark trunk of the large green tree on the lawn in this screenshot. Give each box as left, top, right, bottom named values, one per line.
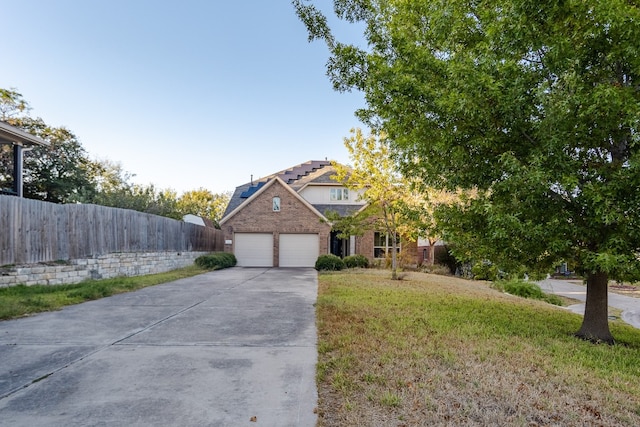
left=576, top=272, right=614, bottom=344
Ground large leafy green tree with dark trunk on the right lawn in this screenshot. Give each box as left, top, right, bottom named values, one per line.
left=293, top=0, right=640, bottom=342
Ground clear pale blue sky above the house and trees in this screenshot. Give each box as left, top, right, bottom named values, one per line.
left=0, top=0, right=364, bottom=193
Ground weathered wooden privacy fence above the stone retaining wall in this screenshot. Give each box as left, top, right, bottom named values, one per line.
left=0, top=195, right=224, bottom=266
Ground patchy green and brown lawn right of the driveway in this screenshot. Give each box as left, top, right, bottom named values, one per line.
left=317, top=270, right=640, bottom=426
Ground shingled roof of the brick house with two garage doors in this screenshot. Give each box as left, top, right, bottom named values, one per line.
left=222, top=160, right=363, bottom=221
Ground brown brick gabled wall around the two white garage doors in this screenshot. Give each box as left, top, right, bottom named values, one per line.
left=222, top=181, right=331, bottom=266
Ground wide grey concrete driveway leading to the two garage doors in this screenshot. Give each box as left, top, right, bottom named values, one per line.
left=0, top=268, right=317, bottom=427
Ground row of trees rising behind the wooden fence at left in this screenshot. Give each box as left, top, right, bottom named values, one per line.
left=0, top=88, right=230, bottom=229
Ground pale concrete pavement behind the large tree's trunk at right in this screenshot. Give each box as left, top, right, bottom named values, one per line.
left=538, top=279, right=640, bottom=328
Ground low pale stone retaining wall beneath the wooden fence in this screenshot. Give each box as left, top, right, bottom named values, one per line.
left=0, top=252, right=207, bottom=287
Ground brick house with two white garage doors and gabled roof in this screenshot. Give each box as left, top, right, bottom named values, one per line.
left=220, top=160, right=373, bottom=267
